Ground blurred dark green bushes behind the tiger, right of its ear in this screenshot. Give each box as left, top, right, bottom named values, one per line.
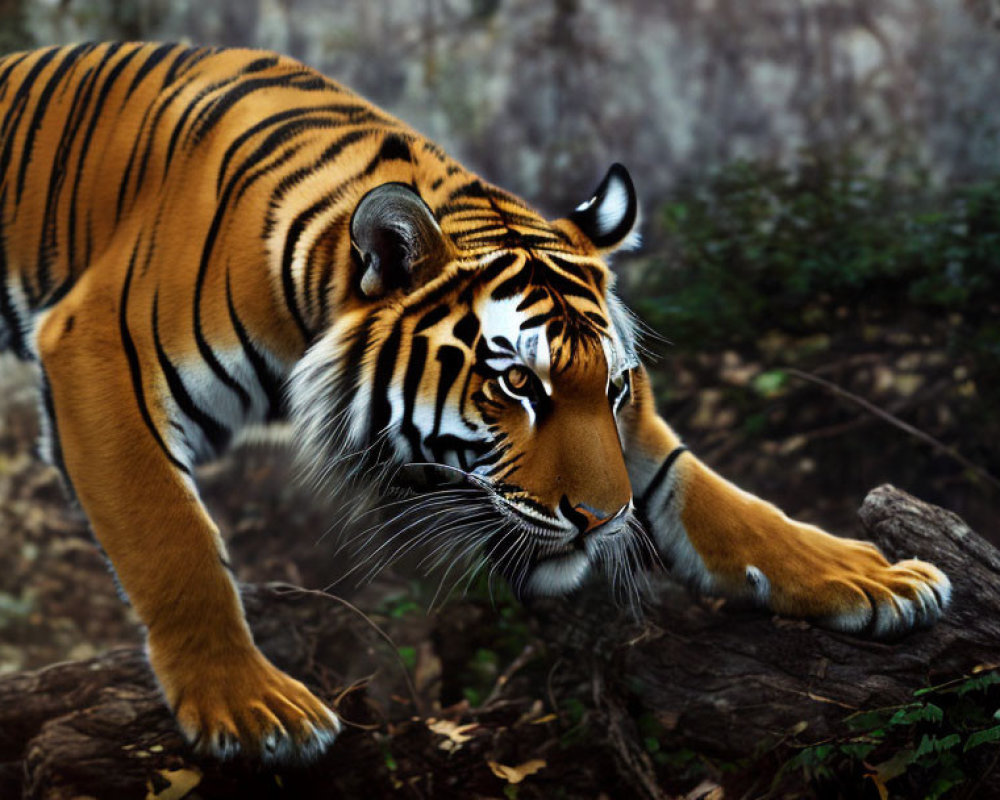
left=635, top=158, right=1000, bottom=401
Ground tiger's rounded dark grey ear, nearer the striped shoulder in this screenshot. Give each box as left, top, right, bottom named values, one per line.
left=351, top=183, right=447, bottom=298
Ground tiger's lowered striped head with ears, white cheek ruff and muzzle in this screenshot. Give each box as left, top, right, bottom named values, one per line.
left=289, top=164, right=646, bottom=596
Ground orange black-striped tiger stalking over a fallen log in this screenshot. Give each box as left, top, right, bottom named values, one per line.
left=0, top=42, right=950, bottom=763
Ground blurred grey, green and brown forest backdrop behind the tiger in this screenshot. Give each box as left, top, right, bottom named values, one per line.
left=0, top=0, right=1000, bottom=556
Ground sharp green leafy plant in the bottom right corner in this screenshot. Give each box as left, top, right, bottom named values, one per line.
left=776, top=669, right=1000, bottom=800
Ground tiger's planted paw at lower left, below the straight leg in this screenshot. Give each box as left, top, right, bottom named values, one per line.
left=161, top=651, right=341, bottom=764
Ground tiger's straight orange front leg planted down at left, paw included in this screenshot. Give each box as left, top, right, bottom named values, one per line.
left=38, top=273, right=340, bottom=761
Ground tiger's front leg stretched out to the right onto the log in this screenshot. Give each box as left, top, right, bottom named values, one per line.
left=619, top=369, right=951, bottom=636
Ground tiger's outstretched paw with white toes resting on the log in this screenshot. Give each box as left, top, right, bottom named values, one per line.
left=764, top=543, right=951, bottom=639
